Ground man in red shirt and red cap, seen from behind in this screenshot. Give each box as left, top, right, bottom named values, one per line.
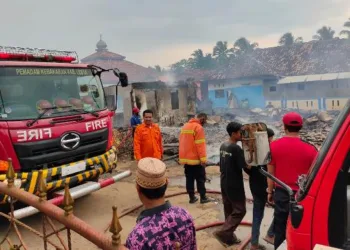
left=267, top=112, right=317, bottom=249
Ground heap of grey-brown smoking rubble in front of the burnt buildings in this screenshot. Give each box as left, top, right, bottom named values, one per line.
left=115, top=109, right=339, bottom=158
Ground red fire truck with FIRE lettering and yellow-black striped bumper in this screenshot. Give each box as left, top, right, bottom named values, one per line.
left=0, top=46, right=128, bottom=206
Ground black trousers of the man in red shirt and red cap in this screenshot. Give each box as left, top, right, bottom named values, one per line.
left=273, top=187, right=289, bottom=249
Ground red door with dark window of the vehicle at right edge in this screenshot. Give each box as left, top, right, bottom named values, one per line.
left=311, top=109, right=350, bottom=249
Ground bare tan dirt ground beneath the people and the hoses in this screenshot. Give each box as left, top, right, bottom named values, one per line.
left=0, top=161, right=273, bottom=250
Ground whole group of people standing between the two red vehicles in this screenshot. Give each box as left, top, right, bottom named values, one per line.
left=122, top=109, right=317, bottom=250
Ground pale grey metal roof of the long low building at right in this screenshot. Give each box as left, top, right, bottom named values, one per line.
left=277, top=72, right=350, bottom=84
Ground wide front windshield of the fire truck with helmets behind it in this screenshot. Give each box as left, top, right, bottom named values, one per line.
left=0, top=67, right=106, bottom=120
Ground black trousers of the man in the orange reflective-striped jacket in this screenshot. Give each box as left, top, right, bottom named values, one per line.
left=185, top=164, right=207, bottom=198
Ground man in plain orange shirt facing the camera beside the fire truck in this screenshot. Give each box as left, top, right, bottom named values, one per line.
left=134, top=109, right=163, bottom=161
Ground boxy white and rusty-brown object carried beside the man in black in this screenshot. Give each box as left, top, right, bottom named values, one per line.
left=241, top=122, right=271, bottom=166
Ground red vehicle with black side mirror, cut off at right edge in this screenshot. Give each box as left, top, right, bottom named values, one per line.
left=264, top=100, right=350, bottom=250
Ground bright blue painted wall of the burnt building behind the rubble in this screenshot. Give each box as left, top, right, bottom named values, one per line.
left=209, top=85, right=265, bottom=108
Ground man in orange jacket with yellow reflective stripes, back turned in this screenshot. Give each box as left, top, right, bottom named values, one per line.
left=179, top=113, right=212, bottom=203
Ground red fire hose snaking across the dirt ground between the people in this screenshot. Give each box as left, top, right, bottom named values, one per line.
left=105, top=190, right=274, bottom=250
